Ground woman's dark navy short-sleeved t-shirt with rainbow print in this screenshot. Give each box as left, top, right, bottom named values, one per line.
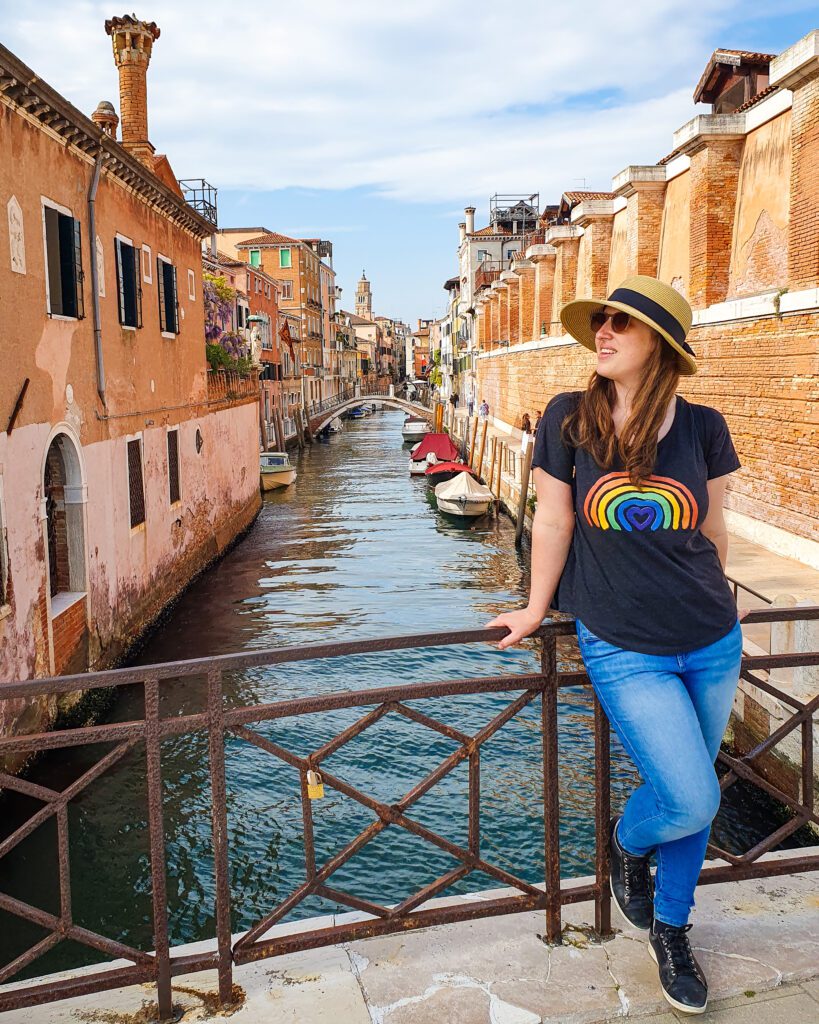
left=532, top=391, right=739, bottom=654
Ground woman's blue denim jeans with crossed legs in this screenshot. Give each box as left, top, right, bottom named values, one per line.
left=576, top=620, right=742, bottom=926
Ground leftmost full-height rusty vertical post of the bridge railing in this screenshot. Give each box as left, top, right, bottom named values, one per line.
left=144, top=676, right=174, bottom=1021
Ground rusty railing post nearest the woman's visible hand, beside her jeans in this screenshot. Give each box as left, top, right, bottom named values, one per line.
left=541, top=636, right=562, bottom=944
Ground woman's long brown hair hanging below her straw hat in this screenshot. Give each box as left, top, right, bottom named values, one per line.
left=561, top=332, right=680, bottom=487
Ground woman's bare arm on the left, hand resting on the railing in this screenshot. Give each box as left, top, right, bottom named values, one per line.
left=486, top=469, right=574, bottom=650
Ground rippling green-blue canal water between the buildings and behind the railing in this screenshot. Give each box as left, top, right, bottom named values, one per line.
left=0, top=410, right=806, bottom=974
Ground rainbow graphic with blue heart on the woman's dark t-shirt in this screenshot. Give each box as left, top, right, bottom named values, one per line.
left=583, top=473, right=698, bottom=532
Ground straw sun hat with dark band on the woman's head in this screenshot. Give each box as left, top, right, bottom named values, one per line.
left=560, top=274, right=697, bottom=376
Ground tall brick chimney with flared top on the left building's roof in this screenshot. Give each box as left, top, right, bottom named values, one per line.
left=105, top=14, right=160, bottom=170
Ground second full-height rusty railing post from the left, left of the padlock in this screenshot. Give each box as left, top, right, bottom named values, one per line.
left=208, top=669, right=233, bottom=1007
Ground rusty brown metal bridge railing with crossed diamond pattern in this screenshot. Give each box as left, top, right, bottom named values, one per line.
left=0, top=606, right=819, bottom=1020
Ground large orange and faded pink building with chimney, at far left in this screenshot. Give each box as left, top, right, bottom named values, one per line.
left=0, top=16, right=260, bottom=733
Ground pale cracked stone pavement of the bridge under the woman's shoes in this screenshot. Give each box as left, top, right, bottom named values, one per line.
left=2, top=854, right=819, bottom=1024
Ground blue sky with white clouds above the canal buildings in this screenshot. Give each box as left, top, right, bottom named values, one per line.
left=0, top=0, right=819, bottom=324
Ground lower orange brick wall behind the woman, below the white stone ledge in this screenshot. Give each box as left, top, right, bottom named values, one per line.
left=478, top=303, right=819, bottom=540
